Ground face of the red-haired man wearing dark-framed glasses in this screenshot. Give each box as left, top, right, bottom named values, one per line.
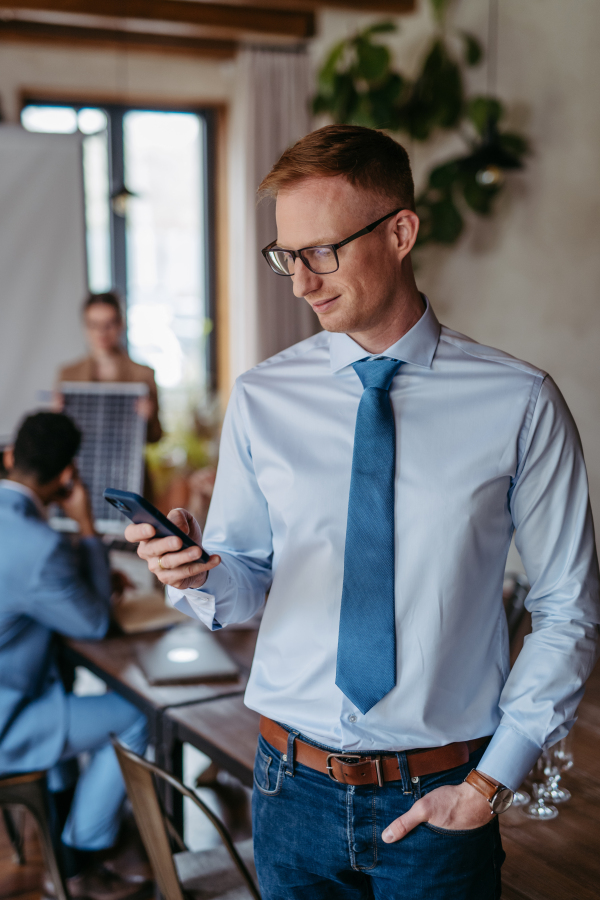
left=276, top=177, right=414, bottom=333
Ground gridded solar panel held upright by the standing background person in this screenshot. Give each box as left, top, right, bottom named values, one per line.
left=57, top=381, right=148, bottom=533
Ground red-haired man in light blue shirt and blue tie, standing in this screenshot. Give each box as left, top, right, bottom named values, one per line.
left=127, top=126, right=599, bottom=900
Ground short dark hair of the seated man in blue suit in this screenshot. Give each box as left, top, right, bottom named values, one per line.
left=13, top=412, right=81, bottom=486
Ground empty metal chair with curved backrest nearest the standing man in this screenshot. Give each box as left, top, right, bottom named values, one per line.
left=113, top=738, right=260, bottom=900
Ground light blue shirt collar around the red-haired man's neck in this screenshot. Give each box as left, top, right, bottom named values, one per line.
left=329, top=294, right=440, bottom=372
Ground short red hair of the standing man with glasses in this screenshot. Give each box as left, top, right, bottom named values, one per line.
left=258, top=125, right=415, bottom=210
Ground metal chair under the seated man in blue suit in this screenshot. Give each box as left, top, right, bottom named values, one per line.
left=0, top=772, right=69, bottom=900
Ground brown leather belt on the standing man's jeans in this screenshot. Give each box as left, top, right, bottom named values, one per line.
left=260, top=716, right=491, bottom=787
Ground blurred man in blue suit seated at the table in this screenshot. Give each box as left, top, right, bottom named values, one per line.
left=0, top=412, right=147, bottom=900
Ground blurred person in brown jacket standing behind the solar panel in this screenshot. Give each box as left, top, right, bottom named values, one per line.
left=57, top=291, right=162, bottom=444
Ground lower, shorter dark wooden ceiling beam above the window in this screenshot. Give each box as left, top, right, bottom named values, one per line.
left=0, top=19, right=238, bottom=59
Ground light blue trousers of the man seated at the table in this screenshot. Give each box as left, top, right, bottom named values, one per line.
left=48, top=693, right=148, bottom=850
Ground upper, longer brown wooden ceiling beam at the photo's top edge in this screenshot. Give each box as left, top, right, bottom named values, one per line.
left=0, top=0, right=315, bottom=38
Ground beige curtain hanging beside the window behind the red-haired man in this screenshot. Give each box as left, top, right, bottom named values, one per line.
left=231, top=47, right=319, bottom=377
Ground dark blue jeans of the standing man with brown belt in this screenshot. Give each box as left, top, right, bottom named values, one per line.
left=252, top=736, right=504, bottom=900
